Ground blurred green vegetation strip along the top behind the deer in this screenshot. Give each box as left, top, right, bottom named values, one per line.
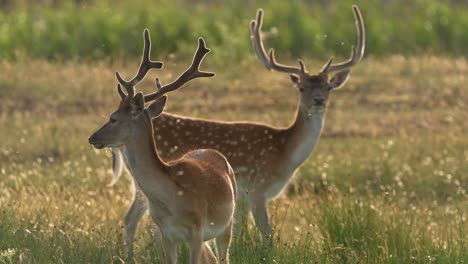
left=0, top=0, right=468, bottom=64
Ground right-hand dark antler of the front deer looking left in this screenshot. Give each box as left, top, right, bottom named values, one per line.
left=145, top=38, right=215, bottom=102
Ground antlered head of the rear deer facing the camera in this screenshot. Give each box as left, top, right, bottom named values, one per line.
left=250, top=5, right=365, bottom=113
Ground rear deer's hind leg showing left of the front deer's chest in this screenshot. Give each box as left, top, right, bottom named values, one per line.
left=124, top=185, right=148, bottom=259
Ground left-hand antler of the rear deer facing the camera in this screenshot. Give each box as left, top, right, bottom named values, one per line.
left=250, top=9, right=306, bottom=74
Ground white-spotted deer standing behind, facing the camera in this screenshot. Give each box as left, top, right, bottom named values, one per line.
left=110, top=5, right=365, bottom=253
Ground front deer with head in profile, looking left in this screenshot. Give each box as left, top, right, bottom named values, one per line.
left=89, top=30, right=237, bottom=264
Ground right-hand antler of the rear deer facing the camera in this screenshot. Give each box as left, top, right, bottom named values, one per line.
left=322, top=5, right=366, bottom=72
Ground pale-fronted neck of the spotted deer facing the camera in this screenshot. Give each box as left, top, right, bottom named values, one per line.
left=286, top=105, right=326, bottom=170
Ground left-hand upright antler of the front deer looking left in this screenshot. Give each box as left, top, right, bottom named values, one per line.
left=115, top=29, right=163, bottom=98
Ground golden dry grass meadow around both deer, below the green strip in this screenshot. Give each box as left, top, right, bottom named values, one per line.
left=0, top=55, right=468, bottom=263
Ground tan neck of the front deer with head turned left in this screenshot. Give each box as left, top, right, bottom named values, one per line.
left=124, top=116, right=176, bottom=202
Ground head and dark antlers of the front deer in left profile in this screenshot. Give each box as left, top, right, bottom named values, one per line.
left=89, top=29, right=215, bottom=149
